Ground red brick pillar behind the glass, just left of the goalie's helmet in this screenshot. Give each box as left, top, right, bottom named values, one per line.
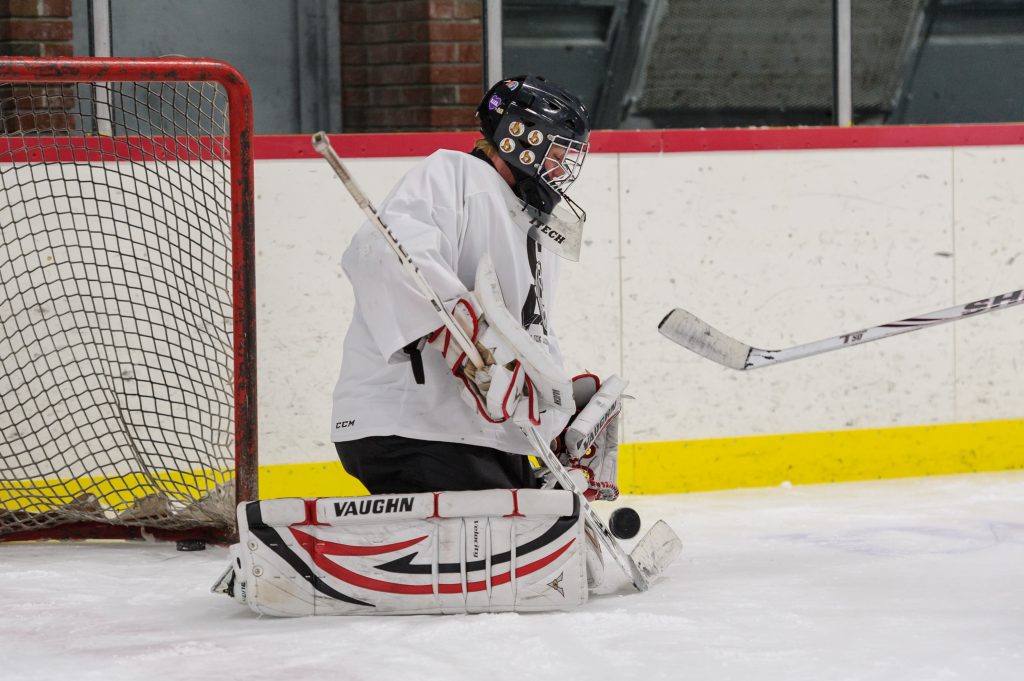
left=341, top=0, right=483, bottom=132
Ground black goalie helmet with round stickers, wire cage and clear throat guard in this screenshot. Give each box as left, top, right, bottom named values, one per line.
left=476, top=76, right=590, bottom=244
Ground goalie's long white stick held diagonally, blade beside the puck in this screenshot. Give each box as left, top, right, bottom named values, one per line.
left=312, top=132, right=682, bottom=591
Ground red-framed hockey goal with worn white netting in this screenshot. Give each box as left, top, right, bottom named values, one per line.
left=0, top=58, right=257, bottom=540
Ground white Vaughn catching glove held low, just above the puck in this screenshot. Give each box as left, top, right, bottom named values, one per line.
left=552, top=374, right=627, bottom=501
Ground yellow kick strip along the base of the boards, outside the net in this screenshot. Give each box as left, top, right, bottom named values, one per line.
left=259, top=420, right=1024, bottom=499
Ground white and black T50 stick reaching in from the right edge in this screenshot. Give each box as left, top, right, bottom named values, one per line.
left=657, top=289, right=1024, bottom=371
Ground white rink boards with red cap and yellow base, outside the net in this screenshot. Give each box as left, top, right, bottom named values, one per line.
left=247, top=125, right=1024, bottom=496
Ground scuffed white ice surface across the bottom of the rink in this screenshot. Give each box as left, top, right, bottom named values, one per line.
left=0, top=472, right=1024, bottom=681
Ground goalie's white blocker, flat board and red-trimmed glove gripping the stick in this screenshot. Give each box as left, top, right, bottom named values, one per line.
left=427, top=256, right=575, bottom=426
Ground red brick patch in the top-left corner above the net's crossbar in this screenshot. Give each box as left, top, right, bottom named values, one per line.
left=0, top=0, right=72, bottom=56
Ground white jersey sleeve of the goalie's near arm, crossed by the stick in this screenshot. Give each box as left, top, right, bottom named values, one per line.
left=342, top=157, right=468, bottom=361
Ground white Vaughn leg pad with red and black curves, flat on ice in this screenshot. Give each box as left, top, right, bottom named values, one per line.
left=213, top=490, right=587, bottom=616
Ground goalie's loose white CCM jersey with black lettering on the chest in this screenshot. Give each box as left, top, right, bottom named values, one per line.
left=332, top=150, right=567, bottom=454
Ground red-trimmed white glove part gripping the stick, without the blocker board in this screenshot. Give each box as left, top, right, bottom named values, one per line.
left=427, top=293, right=540, bottom=423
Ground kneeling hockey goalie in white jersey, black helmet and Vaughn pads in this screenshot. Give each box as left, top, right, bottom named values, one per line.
left=216, top=76, right=625, bottom=615
